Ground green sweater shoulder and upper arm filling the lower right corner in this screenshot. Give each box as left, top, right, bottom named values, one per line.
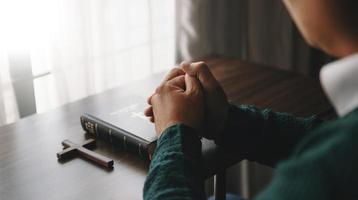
left=256, top=111, right=358, bottom=200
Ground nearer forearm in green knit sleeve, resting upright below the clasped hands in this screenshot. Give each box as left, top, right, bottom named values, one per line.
left=143, top=125, right=205, bottom=200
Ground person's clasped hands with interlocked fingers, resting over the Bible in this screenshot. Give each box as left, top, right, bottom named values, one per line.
left=144, top=62, right=229, bottom=139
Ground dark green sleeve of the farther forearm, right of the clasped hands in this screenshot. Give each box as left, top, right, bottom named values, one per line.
left=216, top=105, right=321, bottom=166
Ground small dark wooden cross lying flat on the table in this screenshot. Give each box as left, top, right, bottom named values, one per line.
left=57, top=139, right=113, bottom=169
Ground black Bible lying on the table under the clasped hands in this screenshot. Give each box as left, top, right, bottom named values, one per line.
left=81, top=96, right=157, bottom=160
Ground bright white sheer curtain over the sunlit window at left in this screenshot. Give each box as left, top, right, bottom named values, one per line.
left=0, top=0, right=175, bottom=125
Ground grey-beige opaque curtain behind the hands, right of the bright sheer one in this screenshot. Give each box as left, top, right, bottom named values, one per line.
left=176, top=0, right=329, bottom=76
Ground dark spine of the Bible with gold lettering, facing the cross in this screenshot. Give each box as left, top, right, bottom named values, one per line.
left=81, top=116, right=151, bottom=160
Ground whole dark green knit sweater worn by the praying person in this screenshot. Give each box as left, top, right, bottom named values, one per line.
left=143, top=105, right=358, bottom=200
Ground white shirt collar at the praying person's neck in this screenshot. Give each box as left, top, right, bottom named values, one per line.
left=320, top=54, right=358, bottom=117
